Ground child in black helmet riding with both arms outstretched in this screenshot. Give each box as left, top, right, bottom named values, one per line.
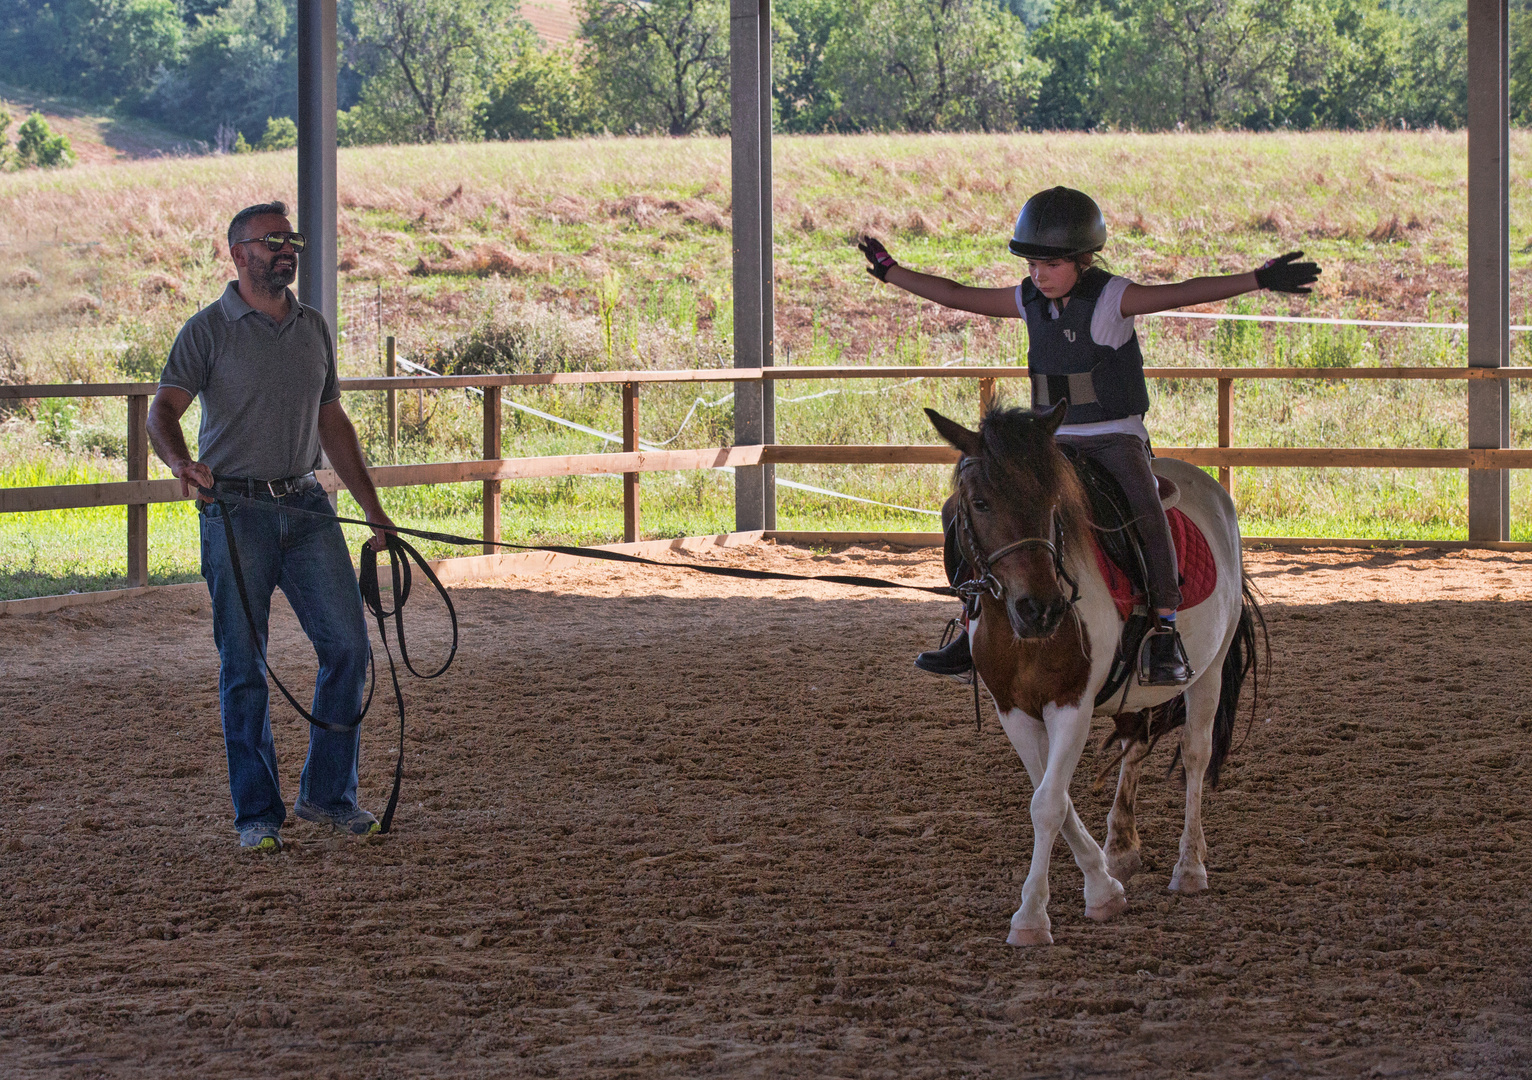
left=858, top=187, right=1321, bottom=686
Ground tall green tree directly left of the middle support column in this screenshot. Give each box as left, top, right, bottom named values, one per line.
left=581, top=0, right=729, bottom=135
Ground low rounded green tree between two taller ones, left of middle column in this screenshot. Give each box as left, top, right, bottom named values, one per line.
left=480, top=46, right=597, bottom=139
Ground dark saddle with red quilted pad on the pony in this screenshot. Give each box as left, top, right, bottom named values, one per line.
left=1059, top=446, right=1218, bottom=705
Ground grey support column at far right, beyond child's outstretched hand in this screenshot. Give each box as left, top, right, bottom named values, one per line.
left=1468, top=0, right=1511, bottom=541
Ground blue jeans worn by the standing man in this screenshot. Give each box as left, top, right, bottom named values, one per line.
left=201, top=484, right=369, bottom=829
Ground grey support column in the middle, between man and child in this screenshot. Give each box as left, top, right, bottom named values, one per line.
left=729, top=0, right=766, bottom=532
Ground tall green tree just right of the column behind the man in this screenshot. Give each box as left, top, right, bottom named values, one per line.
left=352, top=0, right=532, bottom=142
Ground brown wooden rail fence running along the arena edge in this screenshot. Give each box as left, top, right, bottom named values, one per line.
left=0, top=364, right=1532, bottom=588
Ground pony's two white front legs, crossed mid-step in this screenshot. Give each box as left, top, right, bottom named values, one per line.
left=1000, top=705, right=1128, bottom=945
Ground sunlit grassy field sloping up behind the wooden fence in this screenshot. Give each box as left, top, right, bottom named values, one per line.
left=0, top=132, right=1532, bottom=588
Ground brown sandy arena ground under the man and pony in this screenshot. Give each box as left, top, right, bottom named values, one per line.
left=0, top=545, right=1532, bottom=1080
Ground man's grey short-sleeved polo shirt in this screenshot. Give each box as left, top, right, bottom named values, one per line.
left=159, top=282, right=340, bottom=479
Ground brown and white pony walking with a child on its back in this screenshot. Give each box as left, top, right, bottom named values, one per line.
left=925, top=403, right=1259, bottom=945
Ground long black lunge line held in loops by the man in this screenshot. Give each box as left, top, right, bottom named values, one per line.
left=198, top=487, right=953, bottom=833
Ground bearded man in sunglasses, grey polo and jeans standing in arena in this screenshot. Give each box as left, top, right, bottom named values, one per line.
left=149, top=202, right=394, bottom=852
